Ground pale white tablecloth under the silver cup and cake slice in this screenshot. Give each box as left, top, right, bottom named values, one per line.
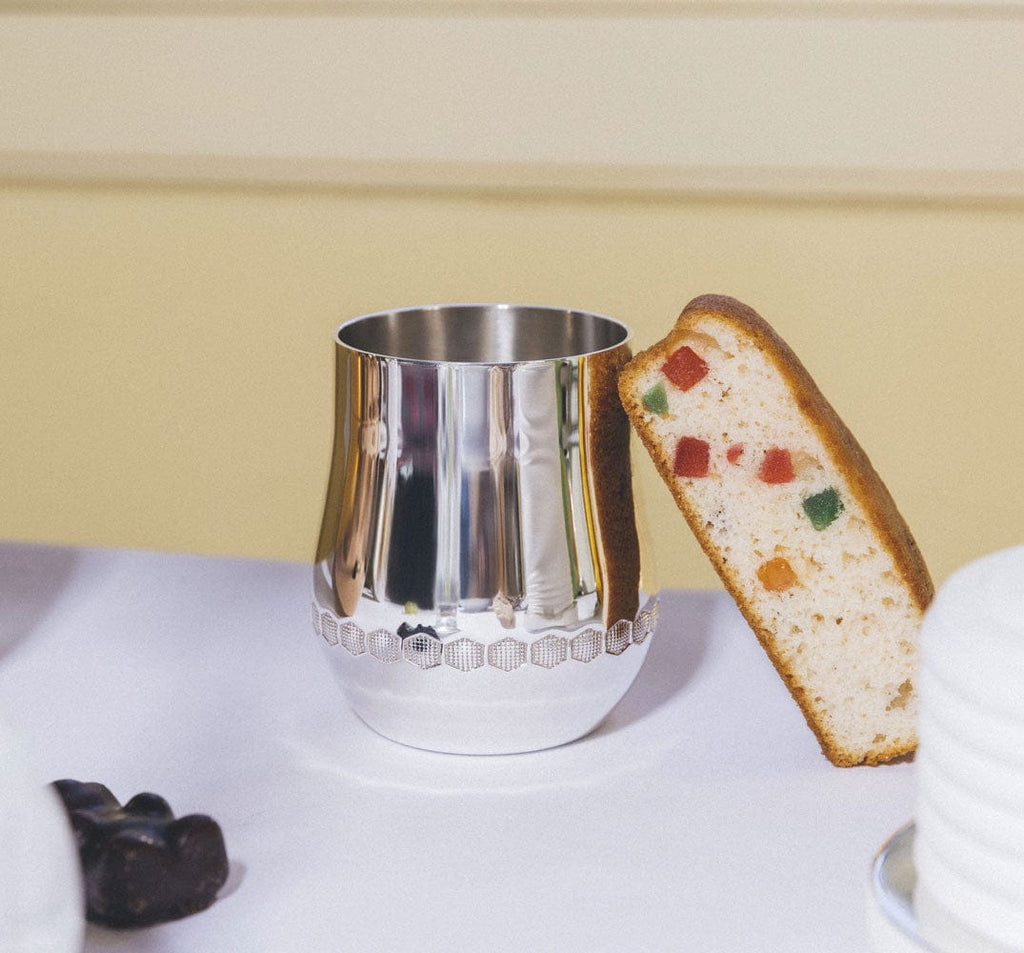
left=0, top=544, right=913, bottom=953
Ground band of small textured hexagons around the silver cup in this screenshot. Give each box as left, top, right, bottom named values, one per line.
left=311, top=599, right=657, bottom=672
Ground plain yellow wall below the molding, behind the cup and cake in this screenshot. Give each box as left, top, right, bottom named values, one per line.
left=0, top=177, right=1024, bottom=586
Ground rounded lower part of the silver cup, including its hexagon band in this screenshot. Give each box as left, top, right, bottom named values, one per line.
left=313, top=600, right=656, bottom=754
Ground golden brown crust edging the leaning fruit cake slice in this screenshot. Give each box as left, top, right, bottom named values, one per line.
left=618, top=295, right=934, bottom=767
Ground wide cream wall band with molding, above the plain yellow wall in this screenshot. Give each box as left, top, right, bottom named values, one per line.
left=0, top=7, right=1024, bottom=203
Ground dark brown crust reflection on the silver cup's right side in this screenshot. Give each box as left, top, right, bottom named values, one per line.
left=585, top=344, right=640, bottom=625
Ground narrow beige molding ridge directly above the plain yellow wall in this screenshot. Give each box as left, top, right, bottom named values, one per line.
left=8, top=151, right=1024, bottom=206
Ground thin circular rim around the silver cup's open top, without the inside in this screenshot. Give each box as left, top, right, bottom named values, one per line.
left=334, top=301, right=633, bottom=367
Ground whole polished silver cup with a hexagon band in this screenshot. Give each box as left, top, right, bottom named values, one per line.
left=312, top=304, right=657, bottom=753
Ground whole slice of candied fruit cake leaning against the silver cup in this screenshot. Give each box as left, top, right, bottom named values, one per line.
left=618, top=295, right=933, bottom=766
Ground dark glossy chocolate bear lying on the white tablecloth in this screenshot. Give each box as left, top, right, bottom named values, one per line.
left=53, top=779, right=227, bottom=926
